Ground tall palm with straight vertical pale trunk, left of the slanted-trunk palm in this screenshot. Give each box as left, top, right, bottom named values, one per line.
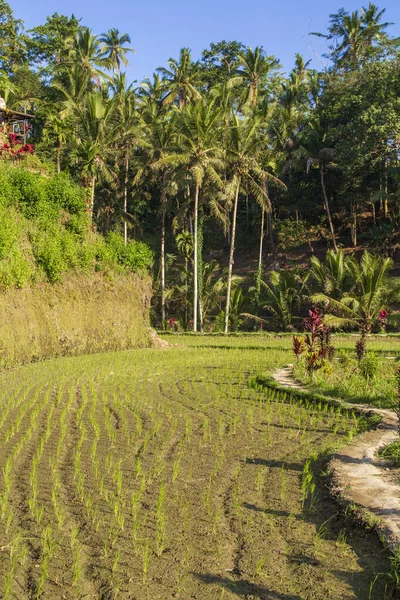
left=153, top=100, right=223, bottom=331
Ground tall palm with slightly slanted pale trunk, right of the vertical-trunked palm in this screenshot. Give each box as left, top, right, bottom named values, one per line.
left=225, top=115, right=285, bottom=333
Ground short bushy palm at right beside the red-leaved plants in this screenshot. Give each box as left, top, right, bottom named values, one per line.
left=311, top=252, right=400, bottom=358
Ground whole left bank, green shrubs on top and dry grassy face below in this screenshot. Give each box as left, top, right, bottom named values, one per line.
left=0, top=161, right=153, bottom=366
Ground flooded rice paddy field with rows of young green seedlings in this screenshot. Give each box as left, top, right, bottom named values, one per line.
left=0, top=335, right=398, bottom=600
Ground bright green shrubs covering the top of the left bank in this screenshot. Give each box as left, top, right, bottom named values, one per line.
left=0, top=161, right=153, bottom=290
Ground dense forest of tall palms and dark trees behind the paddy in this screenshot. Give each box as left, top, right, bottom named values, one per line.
left=0, top=0, right=400, bottom=331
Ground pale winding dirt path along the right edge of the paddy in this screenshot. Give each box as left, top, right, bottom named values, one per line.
left=273, top=366, right=400, bottom=545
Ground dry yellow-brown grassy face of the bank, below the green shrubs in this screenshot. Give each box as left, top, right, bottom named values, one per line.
left=0, top=273, right=151, bottom=367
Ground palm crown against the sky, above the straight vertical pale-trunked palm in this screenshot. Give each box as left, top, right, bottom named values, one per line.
left=157, top=48, right=202, bottom=110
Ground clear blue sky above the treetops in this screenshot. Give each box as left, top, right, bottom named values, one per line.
left=8, top=0, right=400, bottom=81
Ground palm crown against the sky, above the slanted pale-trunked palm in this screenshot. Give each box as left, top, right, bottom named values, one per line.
left=229, top=46, right=280, bottom=108
